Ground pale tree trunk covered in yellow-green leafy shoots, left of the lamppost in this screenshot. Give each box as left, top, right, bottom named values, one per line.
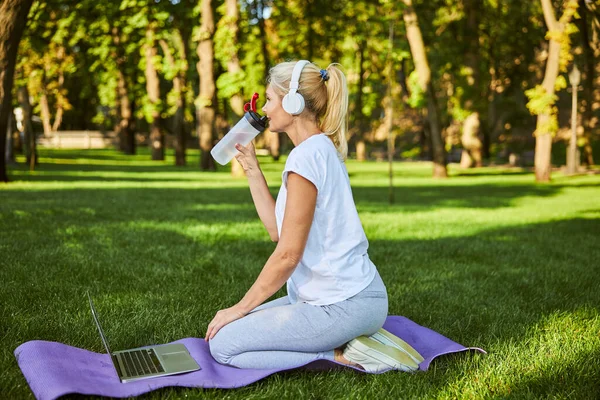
left=526, top=0, right=578, bottom=182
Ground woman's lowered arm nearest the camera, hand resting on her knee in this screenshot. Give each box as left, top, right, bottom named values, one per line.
left=206, top=172, right=317, bottom=340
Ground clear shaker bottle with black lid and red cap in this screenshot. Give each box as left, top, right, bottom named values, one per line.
left=210, top=93, right=267, bottom=165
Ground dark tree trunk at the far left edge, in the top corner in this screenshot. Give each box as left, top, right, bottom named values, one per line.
left=0, top=0, right=33, bottom=182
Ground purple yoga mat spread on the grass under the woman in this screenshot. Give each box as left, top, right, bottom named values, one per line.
left=15, top=316, right=485, bottom=400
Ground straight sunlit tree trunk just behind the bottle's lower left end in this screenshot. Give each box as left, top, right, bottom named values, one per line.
left=196, top=0, right=216, bottom=171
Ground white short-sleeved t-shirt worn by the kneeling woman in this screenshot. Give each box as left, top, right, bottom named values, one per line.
left=275, top=134, right=376, bottom=305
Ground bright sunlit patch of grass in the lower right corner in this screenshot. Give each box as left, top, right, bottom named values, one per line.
left=439, top=309, right=600, bottom=398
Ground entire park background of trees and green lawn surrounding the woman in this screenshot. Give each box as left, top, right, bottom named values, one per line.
left=0, top=0, right=600, bottom=398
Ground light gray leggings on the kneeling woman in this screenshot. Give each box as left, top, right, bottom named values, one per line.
left=209, top=273, right=388, bottom=369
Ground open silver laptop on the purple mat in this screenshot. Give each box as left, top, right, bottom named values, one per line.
left=87, top=293, right=200, bottom=383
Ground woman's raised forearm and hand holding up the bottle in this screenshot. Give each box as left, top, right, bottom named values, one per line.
left=236, top=142, right=279, bottom=242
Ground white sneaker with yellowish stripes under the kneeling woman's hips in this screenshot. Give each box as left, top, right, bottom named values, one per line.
left=344, top=336, right=419, bottom=372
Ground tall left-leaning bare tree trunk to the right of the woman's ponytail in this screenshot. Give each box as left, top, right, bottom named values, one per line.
left=403, top=0, right=448, bottom=178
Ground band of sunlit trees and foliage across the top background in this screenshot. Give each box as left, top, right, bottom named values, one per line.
left=2, top=0, right=600, bottom=180
